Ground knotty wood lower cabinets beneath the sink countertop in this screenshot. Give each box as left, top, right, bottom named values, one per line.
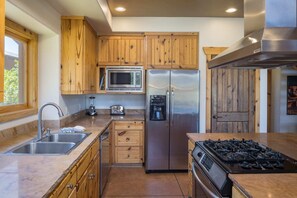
left=50, top=141, right=99, bottom=198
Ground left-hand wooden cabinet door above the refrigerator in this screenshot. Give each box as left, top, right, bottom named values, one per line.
left=146, top=35, right=171, bottom=69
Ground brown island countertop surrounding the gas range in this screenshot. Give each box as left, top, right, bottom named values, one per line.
left=187, top=133, right=297, bottom=198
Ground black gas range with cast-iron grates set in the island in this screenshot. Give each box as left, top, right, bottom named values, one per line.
left=192, top=139, right=297, bottom=197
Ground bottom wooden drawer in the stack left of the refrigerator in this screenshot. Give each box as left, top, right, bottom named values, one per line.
left=115, top=146, right=143, bottom=163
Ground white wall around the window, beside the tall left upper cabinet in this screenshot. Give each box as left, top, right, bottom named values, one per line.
left=0, top=0, right=85, bottom=130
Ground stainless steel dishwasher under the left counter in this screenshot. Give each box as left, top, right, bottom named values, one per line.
left=100, top=128, right=111, bottom=197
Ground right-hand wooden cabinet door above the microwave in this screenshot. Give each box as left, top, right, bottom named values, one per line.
left=120, top=36, right=144, bottom=65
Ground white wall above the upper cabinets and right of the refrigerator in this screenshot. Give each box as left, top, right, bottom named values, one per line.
left=112, top=17, right=244, bottom=132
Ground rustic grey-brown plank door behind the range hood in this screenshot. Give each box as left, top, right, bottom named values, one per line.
left=211, top=69, right=255, bottom=132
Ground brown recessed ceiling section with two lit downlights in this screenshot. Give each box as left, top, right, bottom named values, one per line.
left=107, top=0, right=243, bottom=17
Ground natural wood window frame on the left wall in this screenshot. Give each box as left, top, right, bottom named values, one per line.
left=0, top=18, right=38, bottom=122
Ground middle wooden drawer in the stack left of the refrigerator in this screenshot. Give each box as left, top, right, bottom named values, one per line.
left=115, top=130, right=142, bottom=146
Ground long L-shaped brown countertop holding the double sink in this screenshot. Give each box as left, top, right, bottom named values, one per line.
left=0, top=115, right=144, bottom=198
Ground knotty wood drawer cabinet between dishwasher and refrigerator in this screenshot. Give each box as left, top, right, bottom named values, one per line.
left=113, top=121, right=144, bottom=164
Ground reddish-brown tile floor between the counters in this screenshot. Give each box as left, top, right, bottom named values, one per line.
left=103, top=167, right=188, bottom=198
